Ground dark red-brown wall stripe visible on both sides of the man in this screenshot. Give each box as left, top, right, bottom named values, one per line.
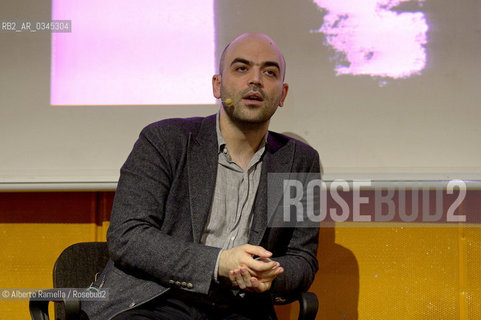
left=0, top=190, right=481, bottom=226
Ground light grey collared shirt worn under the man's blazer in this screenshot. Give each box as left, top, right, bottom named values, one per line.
left=201, top=113, right=267, bottom=279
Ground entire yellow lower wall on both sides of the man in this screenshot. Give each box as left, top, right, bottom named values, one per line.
left=0, top=222, right=481, bottom=320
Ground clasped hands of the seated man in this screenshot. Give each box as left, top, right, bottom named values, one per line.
left=219, top=244, right=284, bottom=292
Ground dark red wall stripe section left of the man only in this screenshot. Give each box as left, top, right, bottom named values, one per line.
left=0, top=191, right=114, bottom=225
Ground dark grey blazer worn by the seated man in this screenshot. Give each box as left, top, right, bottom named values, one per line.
left=82, top=115, right=320, bottom=320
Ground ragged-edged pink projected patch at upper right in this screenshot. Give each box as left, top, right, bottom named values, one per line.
left=313, top=0, right=428, bottom=78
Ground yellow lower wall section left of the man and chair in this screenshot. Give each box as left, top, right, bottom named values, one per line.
left=0, top=223, right=103, bottom=320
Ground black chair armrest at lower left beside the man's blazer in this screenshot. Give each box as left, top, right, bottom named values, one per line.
left=29, top=289, right=80, bottom=320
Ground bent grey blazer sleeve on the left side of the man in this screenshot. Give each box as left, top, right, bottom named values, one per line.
left=107, top=127, right=220, bottom=293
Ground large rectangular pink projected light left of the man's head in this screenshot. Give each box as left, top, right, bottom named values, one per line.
left=50, top=0, right=215, bottom=105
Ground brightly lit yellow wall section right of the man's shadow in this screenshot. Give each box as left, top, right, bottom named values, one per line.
left=330, top=224, right=464, bottom=320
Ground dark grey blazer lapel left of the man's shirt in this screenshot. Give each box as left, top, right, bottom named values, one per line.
left=187, top=115, right=218, bottom=243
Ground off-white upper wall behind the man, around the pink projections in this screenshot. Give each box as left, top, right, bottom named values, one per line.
left=0, top=0, right=481, bottom=190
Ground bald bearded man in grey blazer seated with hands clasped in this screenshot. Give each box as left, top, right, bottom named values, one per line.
left=83, top=33, right=320, bottom=320
